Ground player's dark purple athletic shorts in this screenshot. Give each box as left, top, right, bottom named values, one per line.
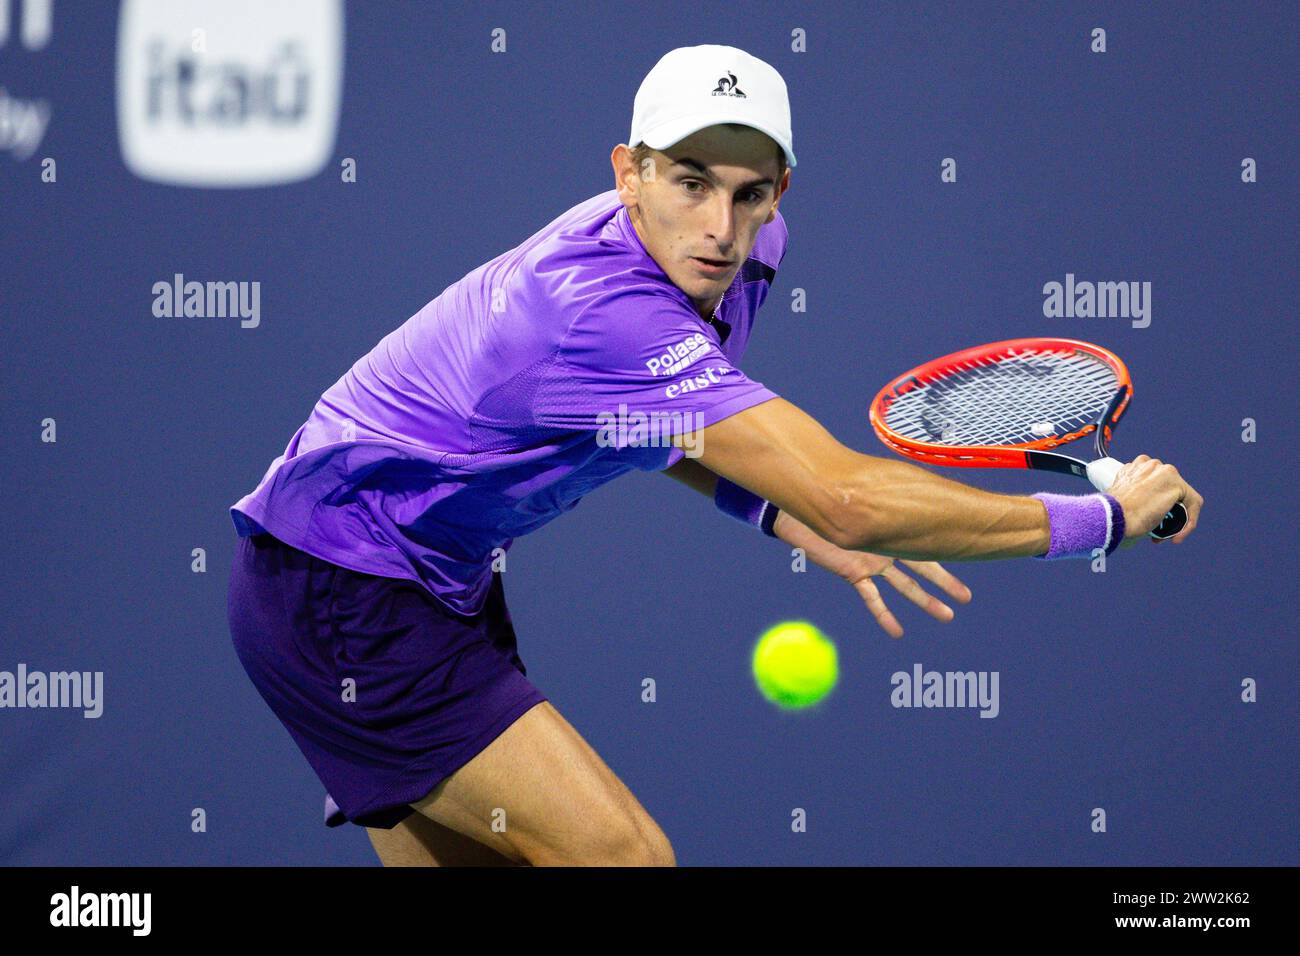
left=229, top=535, right=546, bottom=830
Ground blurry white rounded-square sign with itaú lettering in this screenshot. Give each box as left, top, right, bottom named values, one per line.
left=117, top=0, right=343, bottom=187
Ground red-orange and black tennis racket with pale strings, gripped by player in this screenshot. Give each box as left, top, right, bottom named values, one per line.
left=871, top=338, right=1187, bottom=540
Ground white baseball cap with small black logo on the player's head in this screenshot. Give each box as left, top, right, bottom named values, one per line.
left=628, top=44, right=794, bottom=166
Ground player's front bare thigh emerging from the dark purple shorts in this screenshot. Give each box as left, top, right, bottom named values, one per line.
left=411, top=701, right=676, bottom=866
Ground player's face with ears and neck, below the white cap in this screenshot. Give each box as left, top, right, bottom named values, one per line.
left=615, top=126, right=790, bottom=317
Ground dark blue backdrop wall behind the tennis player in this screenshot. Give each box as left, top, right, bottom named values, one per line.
left=0, top=0, right=1297, bottom=865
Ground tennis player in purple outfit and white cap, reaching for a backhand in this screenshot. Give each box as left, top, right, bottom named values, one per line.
left=220, top=46, right=1201, bottom=865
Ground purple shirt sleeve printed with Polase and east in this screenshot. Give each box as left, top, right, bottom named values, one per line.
left=534, top=289, right=776, bottom=468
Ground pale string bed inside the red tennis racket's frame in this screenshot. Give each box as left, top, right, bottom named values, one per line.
left=885, top=350, right=1119, bottom=445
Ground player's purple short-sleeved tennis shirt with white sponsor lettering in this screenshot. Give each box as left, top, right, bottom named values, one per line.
left=230, top=190, right=788, bottom=614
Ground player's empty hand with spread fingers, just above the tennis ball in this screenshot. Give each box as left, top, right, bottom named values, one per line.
left=774, top=511, right=971, bottom=637
